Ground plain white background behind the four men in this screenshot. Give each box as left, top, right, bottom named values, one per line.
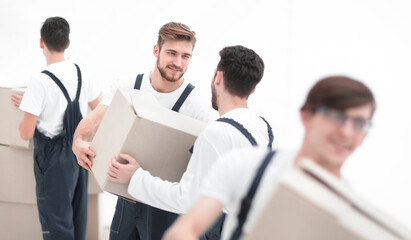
left=0, top=0, right=411, bottom=231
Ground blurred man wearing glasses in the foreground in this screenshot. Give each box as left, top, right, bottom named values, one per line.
left=164, top=76, right=375, bottom=240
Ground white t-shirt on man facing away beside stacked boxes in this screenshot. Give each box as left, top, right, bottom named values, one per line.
left=20, top=60, right=101, bottom=138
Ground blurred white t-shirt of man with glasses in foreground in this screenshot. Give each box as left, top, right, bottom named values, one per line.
left=199, top=147, right=296, bottom=239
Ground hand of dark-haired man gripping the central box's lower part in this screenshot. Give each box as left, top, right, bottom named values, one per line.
left=107, top=153, right=140, bottom=184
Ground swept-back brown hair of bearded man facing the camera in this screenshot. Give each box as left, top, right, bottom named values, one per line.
left=157, top=22, right=197, bottom=49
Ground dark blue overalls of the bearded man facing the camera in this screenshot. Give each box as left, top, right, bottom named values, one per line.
left=110, top=74, right=194, bottom=240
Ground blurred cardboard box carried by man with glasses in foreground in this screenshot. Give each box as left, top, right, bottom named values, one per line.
left=244, top=160, right=411, bottom=240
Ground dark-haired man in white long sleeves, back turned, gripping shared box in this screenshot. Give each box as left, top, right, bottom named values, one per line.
left=107, top=46, right=273, bottom=239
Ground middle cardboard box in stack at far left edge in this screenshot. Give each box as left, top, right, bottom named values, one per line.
left=0, top=145, right=36, bottom=204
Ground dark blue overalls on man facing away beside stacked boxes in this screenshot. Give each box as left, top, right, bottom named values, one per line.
left=33, top=65, right=88, bottom=240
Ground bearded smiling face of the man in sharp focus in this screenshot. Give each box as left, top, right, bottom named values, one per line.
left=154, top=40, right=193, bottom=82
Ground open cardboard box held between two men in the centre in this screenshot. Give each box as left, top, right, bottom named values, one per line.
left=92, top=90, right=206, bottom=200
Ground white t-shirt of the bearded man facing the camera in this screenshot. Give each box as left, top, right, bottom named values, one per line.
left=100, top=72, right=216, bottom=122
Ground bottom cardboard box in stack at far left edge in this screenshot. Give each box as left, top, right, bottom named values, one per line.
left=0, top=201, right=43, bottom=240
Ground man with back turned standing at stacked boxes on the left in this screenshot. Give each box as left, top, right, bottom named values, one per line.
left=13, top=17, right=101, bottom=239
